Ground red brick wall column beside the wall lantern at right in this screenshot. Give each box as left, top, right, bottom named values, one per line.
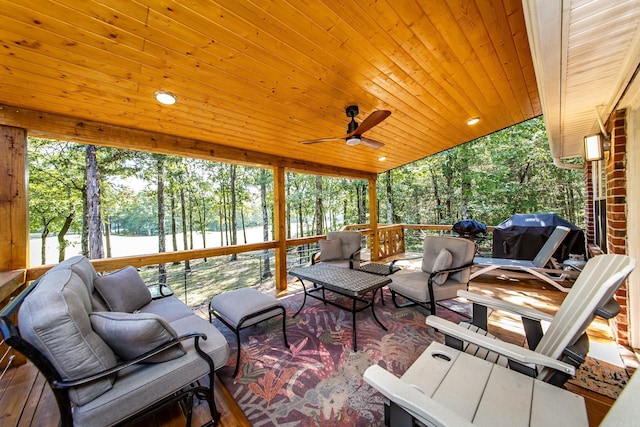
left=606, top=110, right=629, bottom=345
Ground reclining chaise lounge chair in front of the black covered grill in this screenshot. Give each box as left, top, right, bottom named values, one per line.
left=471, top=225, right=579, bottom=292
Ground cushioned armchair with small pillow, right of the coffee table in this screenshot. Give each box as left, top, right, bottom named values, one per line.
left=389, top=236, right=475, bottom=314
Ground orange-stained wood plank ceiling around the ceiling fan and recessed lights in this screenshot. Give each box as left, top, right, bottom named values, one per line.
left=0, top=0, right=542, bottom=173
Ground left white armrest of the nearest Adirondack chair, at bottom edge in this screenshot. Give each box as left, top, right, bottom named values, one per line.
left=364, top=365, right=472, bottom=426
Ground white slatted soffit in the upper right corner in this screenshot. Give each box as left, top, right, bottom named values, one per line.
left=523, top=0, right=640, bottom=159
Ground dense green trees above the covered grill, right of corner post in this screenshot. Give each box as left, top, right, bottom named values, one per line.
left=379, top=117, right=584, bottom=226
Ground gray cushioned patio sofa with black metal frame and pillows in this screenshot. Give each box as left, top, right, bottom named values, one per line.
left=0, top=256, right=229, bottom=426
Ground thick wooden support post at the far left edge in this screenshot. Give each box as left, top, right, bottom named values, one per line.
left=0, top=125, right=29, bottom=271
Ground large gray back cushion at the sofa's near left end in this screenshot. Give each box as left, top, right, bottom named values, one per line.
left=18, top=267, right=116, bottom=405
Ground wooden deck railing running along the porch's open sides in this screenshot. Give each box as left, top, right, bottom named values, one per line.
left=0, top=224, right=498, bottom=369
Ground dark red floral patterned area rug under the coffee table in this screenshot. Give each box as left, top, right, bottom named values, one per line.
left=214, top=290, right=463, bottom=427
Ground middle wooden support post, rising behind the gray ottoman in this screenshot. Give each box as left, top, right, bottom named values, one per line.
left=273, top=166, right=287, bottom=292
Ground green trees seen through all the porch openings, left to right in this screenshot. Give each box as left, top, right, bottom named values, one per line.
left=29, top=118, right=584, bottom=264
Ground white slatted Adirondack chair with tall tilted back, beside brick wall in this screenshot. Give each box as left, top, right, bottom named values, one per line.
left=426, top=254, right=636, bottom=386
